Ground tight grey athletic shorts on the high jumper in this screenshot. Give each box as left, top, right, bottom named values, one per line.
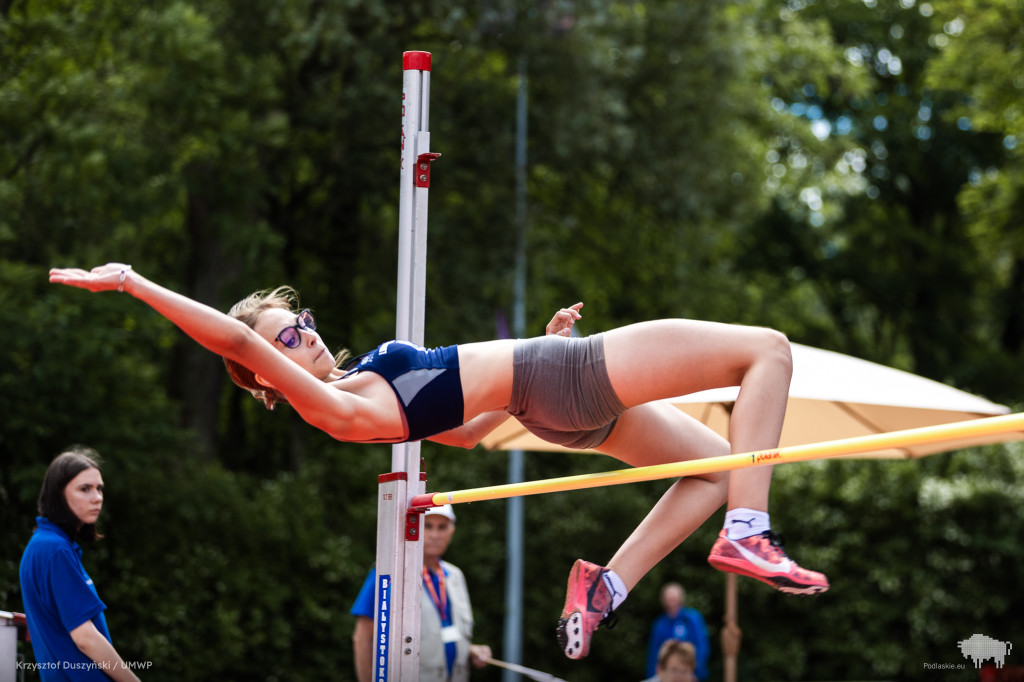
left=508, top=334, right=626, bottom=450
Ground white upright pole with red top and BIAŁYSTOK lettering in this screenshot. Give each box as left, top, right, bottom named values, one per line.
left=373, top=52, right=438, bottom=682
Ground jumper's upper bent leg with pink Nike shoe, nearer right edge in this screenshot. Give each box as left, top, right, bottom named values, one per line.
left=604, top=319, right=828, bottom=594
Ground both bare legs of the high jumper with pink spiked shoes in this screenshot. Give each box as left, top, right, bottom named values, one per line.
left=556, top=319, right=811, bottom=658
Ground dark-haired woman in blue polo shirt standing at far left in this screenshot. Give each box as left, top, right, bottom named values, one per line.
left=20, top=447, right=138, bottom=682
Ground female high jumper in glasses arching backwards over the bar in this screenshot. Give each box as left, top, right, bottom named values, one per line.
left=50, top=263, right=828, bottom=658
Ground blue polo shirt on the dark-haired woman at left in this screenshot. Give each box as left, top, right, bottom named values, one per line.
left=20, top=516, right=111, bottom=682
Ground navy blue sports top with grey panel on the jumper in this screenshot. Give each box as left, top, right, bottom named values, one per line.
left=345, top=341, right=463, bottom=441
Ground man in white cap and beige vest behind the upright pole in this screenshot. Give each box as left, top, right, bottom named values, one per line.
left=349, top=505, right=490, bottom=682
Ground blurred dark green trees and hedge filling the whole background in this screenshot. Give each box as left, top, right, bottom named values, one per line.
left=0, top=0, right=1024, bottom=681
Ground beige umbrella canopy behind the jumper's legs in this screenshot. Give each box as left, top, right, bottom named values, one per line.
left=483, top=343, right=1020, bottom=458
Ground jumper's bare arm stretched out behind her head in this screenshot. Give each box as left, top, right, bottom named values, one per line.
left=50, top=263, right=364, bottom=439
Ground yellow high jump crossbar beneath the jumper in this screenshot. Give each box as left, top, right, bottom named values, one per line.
left=409, top=405, right=1024, bottom=511
